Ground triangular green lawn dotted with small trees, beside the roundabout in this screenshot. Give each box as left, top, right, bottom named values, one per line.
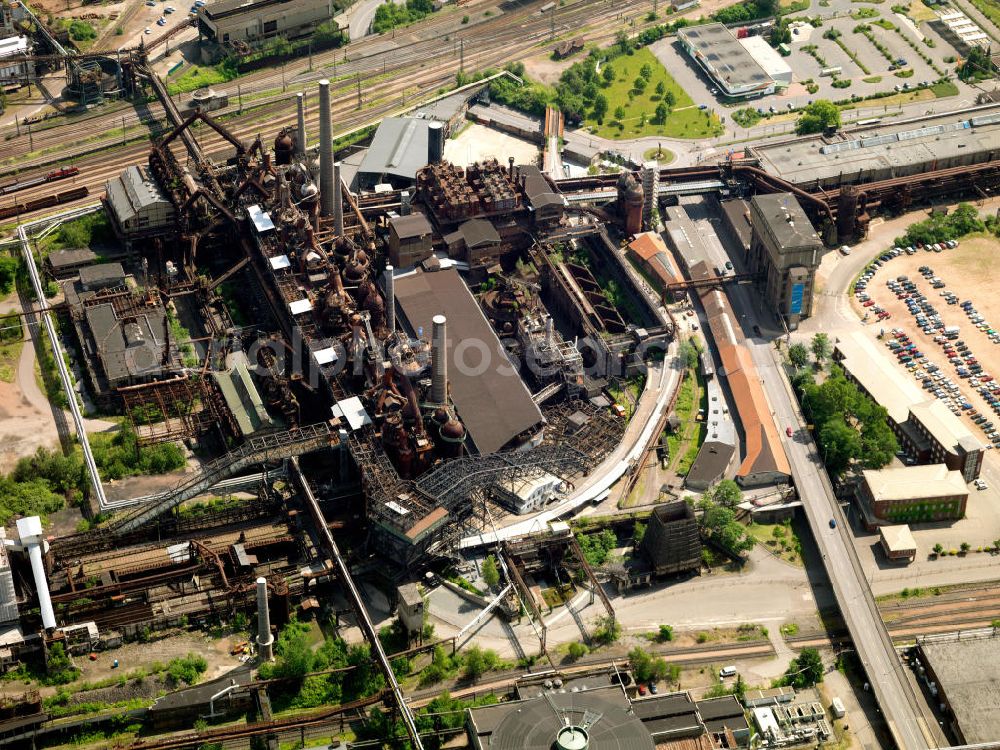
left=586, top=48, right=722, bottom=138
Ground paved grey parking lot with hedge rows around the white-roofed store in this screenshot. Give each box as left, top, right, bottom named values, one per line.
left=650, top=0, right=959, bottom=124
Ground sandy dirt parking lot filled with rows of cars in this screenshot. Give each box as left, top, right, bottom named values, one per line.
left=854, top=238, right=1000, bottom=452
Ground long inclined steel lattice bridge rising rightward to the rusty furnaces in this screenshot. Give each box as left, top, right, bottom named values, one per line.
left=108, top=423, right=336, bottom=535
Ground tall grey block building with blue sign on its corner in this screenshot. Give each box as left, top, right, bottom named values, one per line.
left=748, top=193, right=824, bottom=328
